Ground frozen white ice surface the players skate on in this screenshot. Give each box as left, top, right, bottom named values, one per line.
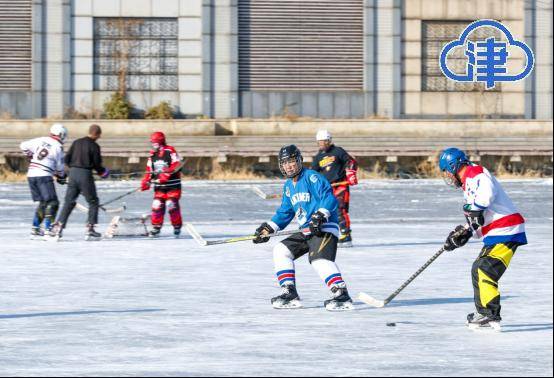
left=0, top=180, right=553, bottom=376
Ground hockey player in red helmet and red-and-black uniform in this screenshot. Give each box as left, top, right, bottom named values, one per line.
left=141, top=131, right=183, bottom=238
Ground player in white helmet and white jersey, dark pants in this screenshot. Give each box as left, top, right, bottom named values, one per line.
left=20, top=123, right=67, bottom=239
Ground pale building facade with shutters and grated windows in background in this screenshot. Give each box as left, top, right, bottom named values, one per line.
left=0, top=0, right=552, bottom=119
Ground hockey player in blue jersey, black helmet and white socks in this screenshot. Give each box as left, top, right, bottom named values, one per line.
left=254, top=145, right=353, bottom=311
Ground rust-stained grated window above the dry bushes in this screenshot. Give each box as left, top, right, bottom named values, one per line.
left=94, top=18, right=178, bottom=91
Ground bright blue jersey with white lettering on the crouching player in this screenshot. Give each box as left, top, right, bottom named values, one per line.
left=270, top=169, right=339, bottom=237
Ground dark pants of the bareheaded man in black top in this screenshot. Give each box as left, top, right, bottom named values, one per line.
left=58, top=168, right=99, bottom=227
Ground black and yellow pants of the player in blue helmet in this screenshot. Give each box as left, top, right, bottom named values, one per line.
left=471, top=242, right=522, bottom=319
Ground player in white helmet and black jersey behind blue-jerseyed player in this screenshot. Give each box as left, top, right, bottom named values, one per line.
left=312, top=130, right=358, bottom=247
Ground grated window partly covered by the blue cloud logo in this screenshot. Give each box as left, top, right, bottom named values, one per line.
left=421, top=21, right=502, bottom=92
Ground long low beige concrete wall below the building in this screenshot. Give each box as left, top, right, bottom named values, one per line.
left=0, top=119, right=553, bottom=139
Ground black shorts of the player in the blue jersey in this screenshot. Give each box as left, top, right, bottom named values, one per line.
left=281, top=232, right=338, bottom=263
